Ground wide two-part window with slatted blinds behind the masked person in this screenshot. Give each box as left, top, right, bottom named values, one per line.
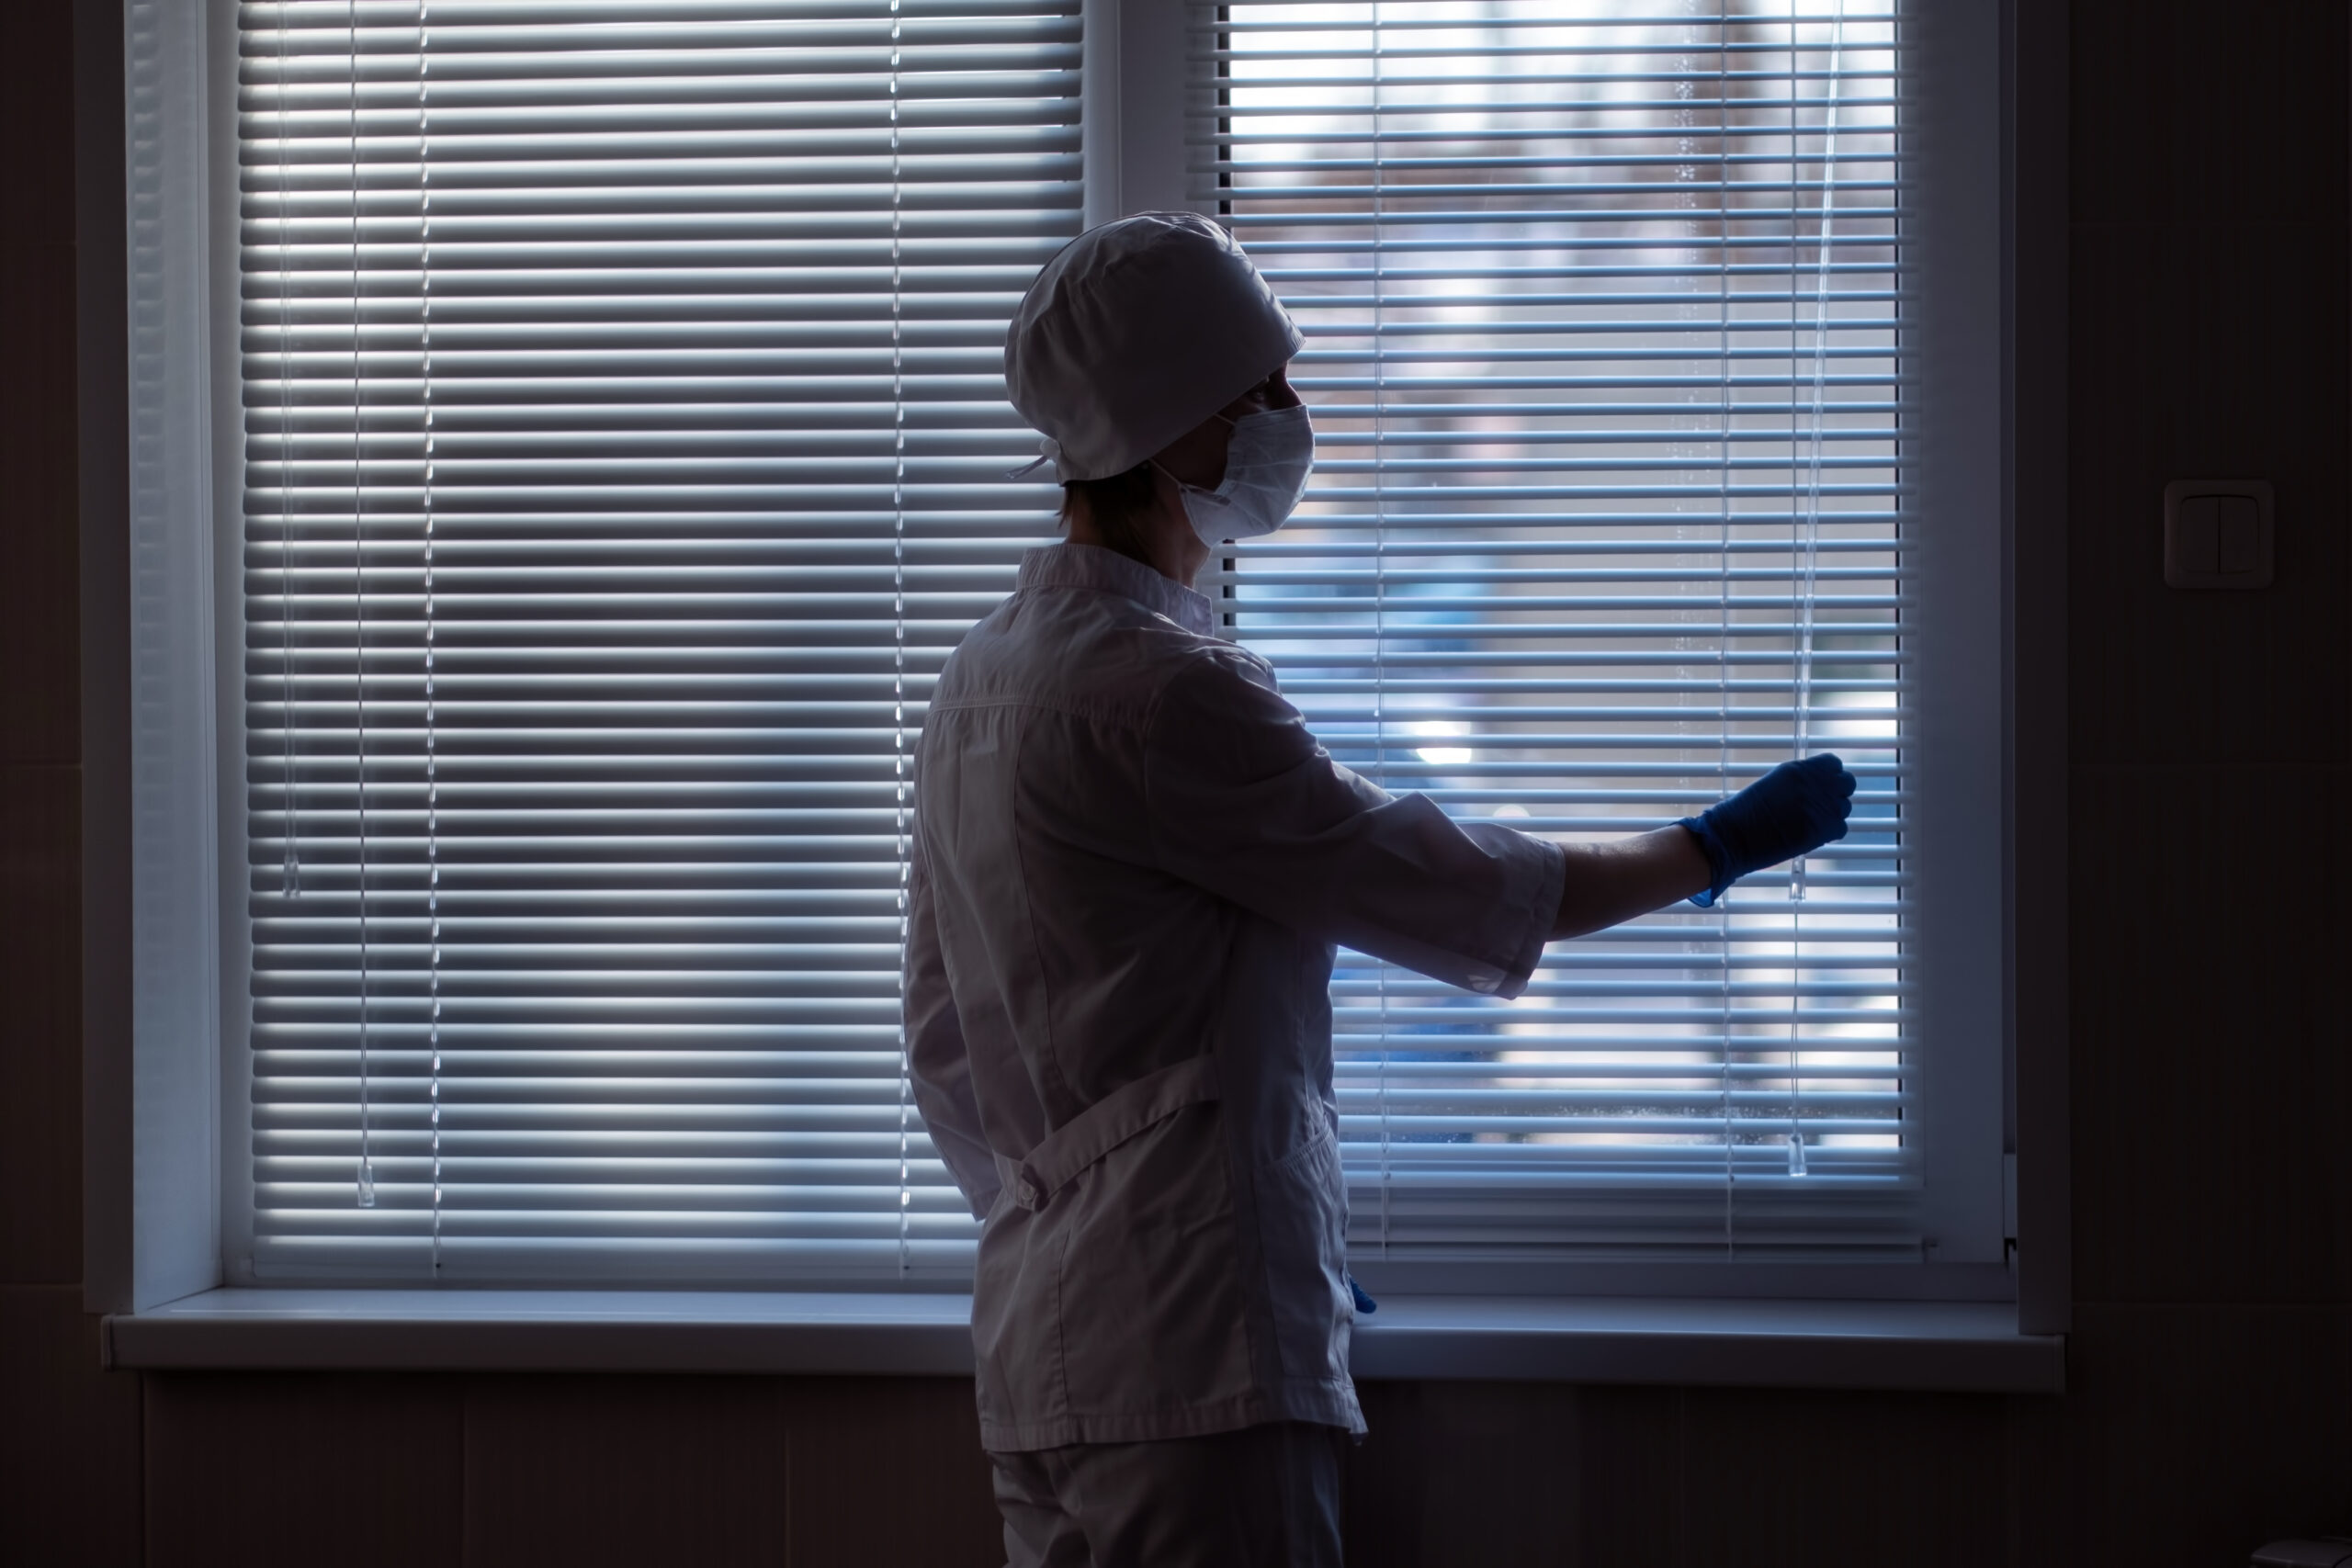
left=165, top=0, right=2007, bottom=1295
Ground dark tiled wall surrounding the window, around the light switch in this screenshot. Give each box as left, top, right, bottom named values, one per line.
left=0, top=0, right=2352, bottom=1568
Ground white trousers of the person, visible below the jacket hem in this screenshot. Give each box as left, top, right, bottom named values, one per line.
left=988, top=1422, right=1348, bottom=1568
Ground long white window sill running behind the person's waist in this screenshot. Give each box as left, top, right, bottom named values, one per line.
left=106, top=1291, right=2065, bottom=1394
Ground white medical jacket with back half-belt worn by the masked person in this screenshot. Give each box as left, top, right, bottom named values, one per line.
left=906, top=546, right=1564, bottom=1450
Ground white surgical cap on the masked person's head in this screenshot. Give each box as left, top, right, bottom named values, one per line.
left=1004, top=211, right=1303, bottom=482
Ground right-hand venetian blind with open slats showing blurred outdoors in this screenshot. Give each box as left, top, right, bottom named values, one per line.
left=1190, top=0, right=1917, bottom=1260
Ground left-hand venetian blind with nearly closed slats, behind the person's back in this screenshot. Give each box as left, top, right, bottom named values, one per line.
left=235, top=0, right=1080, bottom=1281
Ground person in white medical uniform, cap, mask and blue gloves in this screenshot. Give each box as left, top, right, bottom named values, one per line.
left=906, top=211, right=1853, bottom=1568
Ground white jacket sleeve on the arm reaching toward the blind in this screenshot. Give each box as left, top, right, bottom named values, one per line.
left=1143, top=649, right=1566, bottom=997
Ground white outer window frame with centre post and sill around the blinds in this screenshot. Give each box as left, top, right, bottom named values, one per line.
left=75, top=0, right=2067, bottom=1387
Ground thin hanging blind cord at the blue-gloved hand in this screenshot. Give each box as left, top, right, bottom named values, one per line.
left=1788, top=0, right=1847, bottom=1176
